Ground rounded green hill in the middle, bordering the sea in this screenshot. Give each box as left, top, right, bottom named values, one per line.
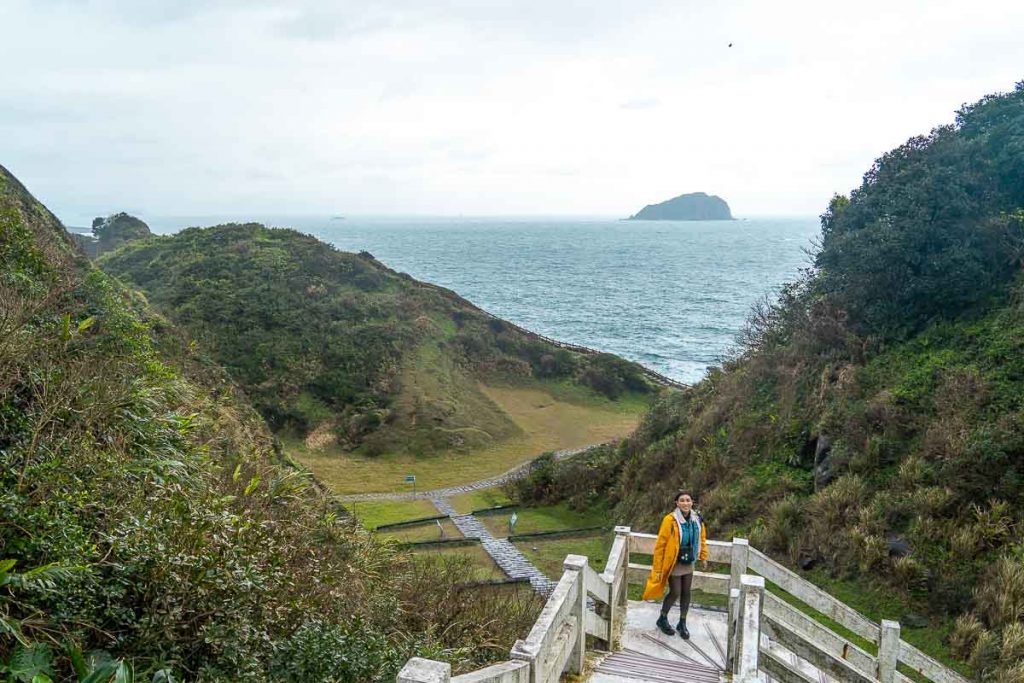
left=100, top=224, right=650, bottom=455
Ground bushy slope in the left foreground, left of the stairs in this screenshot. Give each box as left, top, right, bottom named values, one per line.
left=0, top=167, right=535, bottom=683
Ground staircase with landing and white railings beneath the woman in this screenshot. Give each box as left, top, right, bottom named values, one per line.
left=397, top=526, right=968, bottom=683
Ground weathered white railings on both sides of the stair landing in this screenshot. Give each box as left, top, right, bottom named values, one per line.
left=398, top=526, right=967, bottom=683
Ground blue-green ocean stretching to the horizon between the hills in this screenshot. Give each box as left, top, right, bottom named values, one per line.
left=136, top=216, right=819, bottom=383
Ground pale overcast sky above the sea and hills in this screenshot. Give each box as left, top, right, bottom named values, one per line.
left=0, top=0, right=1024, bottom=224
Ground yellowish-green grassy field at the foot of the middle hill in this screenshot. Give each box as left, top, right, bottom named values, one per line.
left=282, top=383, right=647, bottom=494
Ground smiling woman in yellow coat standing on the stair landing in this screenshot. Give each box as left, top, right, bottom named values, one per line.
left=643, top=490, right=708, bottom=639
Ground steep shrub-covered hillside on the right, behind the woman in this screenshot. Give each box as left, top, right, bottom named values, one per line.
left=523, top=83, right=1024, bottom=681
